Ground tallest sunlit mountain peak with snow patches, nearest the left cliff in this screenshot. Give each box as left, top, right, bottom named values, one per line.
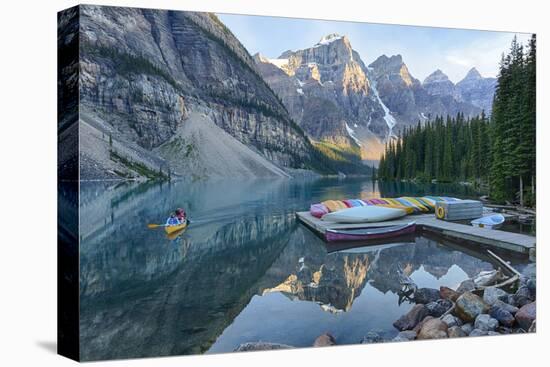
left=255, top=34, right=395, bottom=158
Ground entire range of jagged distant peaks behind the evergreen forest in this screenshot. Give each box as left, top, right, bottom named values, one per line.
left=254, top=34, right=500, bottom=164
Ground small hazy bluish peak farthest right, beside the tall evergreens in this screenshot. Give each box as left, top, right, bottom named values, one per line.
left=456, top=68, right=497, bottom=113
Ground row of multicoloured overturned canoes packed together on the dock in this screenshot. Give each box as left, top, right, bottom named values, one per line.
left=309, top=196, right=460, bottom=218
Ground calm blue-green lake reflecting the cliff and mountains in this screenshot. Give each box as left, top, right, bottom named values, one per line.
left=61, top=178, right=532, bottom=360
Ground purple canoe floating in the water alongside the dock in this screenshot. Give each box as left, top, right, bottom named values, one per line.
left=325, top=222, right=416, bottom=242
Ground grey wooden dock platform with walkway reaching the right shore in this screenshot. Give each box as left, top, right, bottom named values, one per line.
left=296, top=212, right=536, bottom=255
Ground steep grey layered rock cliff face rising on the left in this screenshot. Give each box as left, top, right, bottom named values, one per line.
left=76, top=5, right=322, bottom=178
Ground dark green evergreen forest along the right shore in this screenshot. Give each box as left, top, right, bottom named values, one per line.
left=378, top=35, right=536, bottom=206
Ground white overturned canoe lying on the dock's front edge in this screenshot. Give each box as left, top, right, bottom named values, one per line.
left=321, top=206, right=407, bottom=223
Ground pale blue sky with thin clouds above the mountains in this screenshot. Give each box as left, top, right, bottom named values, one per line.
left=217, top=14, right=531, bottom=83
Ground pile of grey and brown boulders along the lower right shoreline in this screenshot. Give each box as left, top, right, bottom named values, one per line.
left=235, top=264, right=537, bottom=351
